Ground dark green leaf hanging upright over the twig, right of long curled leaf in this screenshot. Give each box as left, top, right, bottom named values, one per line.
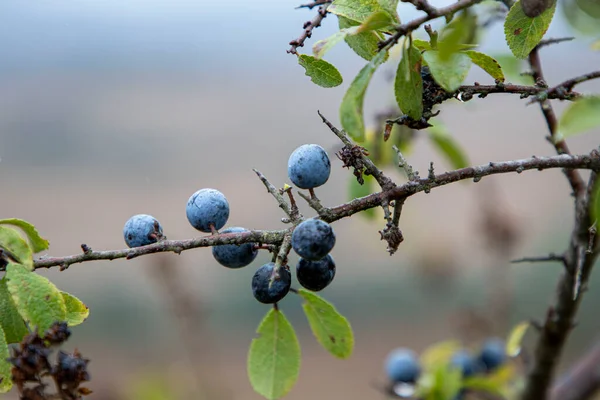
left=394, top=46, right=423, bottom=120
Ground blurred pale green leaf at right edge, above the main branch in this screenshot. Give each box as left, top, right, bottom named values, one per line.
left=558, top=96, right=600, bottom=138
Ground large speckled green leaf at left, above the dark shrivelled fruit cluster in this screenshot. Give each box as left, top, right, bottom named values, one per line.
left=5, top=263, right=67, bottom=333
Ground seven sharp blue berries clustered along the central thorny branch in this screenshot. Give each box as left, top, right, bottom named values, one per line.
left=123, top=144, right=335, bottom=304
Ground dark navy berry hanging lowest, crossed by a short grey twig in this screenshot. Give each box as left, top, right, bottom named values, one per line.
left=252, top=262, right=292, bottom=304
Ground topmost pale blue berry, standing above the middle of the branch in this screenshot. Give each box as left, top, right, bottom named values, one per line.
left=288, top=144, right=331, bottom=189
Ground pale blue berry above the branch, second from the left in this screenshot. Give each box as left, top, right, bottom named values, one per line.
left=185, top=189, right=229, bottom=232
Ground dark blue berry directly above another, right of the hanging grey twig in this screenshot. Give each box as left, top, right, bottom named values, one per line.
left=292, top=219, right=335, bottom=261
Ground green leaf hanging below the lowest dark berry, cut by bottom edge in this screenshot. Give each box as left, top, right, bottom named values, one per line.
left=248, top=309, right=300, bottom=400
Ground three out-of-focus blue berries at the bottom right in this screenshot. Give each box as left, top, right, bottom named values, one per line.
left=385, top=338, right=507, bottom=399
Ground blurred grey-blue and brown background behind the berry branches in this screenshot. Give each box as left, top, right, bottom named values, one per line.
left=0, top=0, right=600, bottom=400
